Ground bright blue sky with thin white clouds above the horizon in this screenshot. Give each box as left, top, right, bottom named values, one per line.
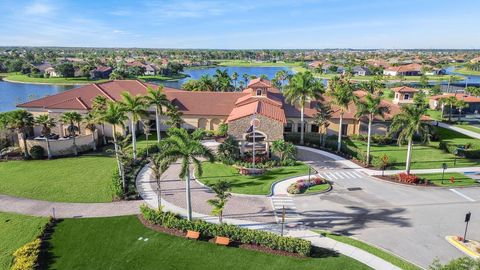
left=0, top=0, right=480, bottom=49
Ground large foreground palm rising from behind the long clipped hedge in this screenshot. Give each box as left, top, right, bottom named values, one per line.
left=160, top=128, right=215, bottom=220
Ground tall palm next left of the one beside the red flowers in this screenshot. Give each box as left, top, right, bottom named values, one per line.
left=355, top=93, right=390, bottom=165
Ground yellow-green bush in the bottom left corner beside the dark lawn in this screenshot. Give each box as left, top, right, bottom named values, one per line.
left=11, top=238, right=42, bottom=270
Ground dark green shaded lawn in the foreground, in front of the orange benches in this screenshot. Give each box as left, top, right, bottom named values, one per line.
left=48, top=216, right=369, bottom=270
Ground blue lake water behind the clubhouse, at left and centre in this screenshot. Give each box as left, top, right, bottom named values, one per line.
left=0, top=67, right=291, bottom=112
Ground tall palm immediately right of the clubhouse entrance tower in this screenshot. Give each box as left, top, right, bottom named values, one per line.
left=284, top=71, right=324, bottom=144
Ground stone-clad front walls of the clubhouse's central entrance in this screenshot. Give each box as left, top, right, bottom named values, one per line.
left=228, top=115, right=283, bottom=142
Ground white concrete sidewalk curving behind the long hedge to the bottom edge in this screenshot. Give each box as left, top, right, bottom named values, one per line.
left=136, top=163, right=400, bottom=270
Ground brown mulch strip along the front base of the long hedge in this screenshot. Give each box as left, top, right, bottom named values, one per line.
left=138, top=215, right=306, bottom=258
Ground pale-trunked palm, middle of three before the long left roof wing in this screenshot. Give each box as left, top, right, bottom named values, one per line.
left=122, top=92, right=147, bottom=159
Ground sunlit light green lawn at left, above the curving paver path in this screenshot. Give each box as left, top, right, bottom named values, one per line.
left=0, top=155, right=115, bottom=202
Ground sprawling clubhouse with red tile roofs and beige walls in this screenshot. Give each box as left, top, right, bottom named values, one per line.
left=17, top=78, right=408, bottom=156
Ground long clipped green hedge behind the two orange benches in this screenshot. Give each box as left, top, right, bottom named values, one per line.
left=140, top=205, right=312, bottom=256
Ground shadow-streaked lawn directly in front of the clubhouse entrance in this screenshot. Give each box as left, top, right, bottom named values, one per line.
left=199, top=162, right=308, bottom=195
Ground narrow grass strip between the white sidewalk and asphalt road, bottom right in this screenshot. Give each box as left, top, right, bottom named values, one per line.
left=315, top=230, right=421, bottom=270
